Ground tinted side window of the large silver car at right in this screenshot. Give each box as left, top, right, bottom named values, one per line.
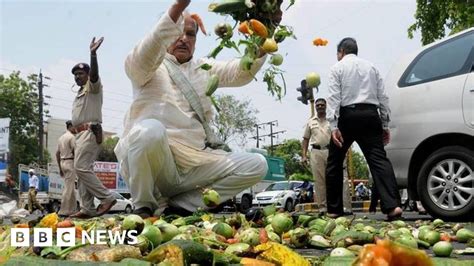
left=402, top=32, right=474, bottom=86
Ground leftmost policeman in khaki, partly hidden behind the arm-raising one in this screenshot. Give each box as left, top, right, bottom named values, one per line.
left=56, top=120, right=76, bottom=216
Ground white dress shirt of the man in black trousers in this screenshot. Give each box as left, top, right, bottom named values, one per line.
left=327, top=54, right=390, bottom=130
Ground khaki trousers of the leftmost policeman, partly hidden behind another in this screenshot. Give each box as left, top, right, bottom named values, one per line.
left=58, top=160, right=77, bottom=216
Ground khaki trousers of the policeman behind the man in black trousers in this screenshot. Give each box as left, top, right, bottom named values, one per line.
left=310, top=149, right=352, bottom=212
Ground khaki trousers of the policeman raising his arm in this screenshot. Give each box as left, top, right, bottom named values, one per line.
left=74, top=130, right=115, bottom=216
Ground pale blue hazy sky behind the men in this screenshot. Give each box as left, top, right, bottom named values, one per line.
left=0, top=0, right=421, bottom=151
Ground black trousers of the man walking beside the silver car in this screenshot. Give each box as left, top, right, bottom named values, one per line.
left=326, top=104, right=400, bottom=214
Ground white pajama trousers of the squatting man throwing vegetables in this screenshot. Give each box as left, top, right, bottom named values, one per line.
left=119, top=119, right=268, bottom=211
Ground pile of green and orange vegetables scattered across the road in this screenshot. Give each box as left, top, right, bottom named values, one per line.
left=0, top=204, right=474, bottom=266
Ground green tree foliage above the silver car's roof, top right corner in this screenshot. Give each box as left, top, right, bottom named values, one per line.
left=408, top=0, right=474, bottom=45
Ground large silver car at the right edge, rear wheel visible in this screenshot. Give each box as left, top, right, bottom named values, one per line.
left=385, top=28, right=474, bottom=221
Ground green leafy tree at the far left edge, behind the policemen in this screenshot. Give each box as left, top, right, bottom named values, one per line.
left=0, top=72, right=50, bottom=180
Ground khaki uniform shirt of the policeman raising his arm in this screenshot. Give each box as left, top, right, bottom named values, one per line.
left=71, top=79, right=103, bottom=127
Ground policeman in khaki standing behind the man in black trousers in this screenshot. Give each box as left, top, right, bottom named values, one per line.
left=302, top=98, right=352, bottom=213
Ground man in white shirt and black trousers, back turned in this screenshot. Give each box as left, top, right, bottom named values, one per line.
left=326, top=38, right=402, bottom=220
